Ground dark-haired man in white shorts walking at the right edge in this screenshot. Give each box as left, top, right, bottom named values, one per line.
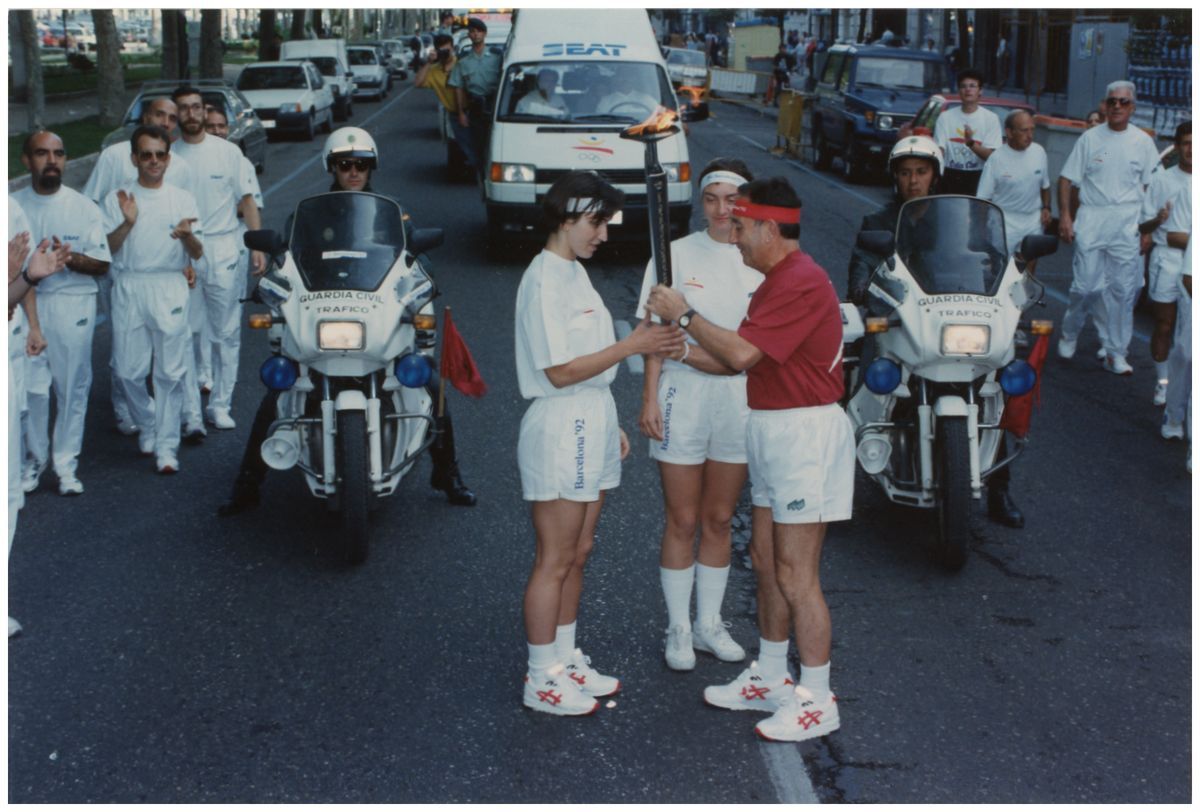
left=1138, top=121, right=1192, bottom=405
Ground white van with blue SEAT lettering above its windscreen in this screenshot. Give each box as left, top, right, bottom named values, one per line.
left=484, top=8, right=691, bottom=243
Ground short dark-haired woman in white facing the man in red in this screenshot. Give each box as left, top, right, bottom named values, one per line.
left=516, top=172, right=684, bottom=716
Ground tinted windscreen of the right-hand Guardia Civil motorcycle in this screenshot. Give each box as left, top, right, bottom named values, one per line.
left=896, top=194, right=1008, bottom=296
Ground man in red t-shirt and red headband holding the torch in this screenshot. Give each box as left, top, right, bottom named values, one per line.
left=647, top=178, right=854, bottom=741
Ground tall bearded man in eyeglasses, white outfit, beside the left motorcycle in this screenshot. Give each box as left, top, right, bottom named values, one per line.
left=172, top=86, right=266, bottom=429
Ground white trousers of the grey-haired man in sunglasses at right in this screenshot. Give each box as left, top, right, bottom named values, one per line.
left=1062, top=203, right=1142, bottom=357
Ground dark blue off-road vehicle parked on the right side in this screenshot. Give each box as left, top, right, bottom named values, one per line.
left=812, top=44, right=954, bottom=179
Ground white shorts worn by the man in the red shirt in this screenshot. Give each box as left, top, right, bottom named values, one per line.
left=746, top=403, right=854, bottom=524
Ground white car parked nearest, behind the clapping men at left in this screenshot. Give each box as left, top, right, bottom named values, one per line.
left=238, top=60, right=334, bottom=142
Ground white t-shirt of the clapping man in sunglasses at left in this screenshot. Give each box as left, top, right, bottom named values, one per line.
left=102, top=181, right=204, bottom=273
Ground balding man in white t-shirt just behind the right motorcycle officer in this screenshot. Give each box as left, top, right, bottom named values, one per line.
left=976, top=110, right=1050, bottom=263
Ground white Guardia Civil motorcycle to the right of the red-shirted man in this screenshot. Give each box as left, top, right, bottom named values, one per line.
left=842, top=196, right=1057, bottom=571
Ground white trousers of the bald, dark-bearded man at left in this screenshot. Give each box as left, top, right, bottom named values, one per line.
left=25, top=293, right=96, bottom=476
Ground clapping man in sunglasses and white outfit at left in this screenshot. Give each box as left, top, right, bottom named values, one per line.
left=103, top=126, right=204, bottom=474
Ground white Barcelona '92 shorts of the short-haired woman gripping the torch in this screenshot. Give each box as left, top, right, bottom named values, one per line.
left=517, top=387, right=620, bottom=501
